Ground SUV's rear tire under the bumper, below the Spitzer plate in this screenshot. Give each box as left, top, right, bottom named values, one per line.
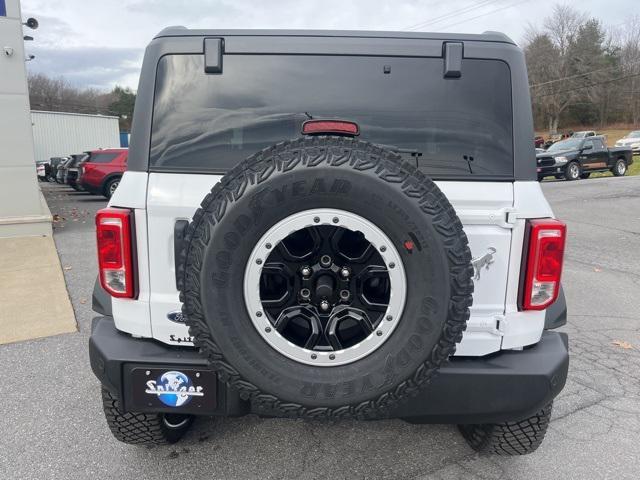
left=102, top=387, right=193, bottom=445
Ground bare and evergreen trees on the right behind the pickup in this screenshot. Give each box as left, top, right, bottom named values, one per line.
left=523, top=5, right=640, bottom=132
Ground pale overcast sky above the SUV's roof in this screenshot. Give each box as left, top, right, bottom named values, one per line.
left=22, top=0, right=639, bottom=89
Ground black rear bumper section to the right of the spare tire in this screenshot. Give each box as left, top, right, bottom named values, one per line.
left=396, top=332, right=569, bottom=423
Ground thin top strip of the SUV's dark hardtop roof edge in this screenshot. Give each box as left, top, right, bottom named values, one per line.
left=155, top=26, right=515, bottom=45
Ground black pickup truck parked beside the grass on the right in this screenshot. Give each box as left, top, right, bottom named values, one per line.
left=536, top=136, right=633, bottom=180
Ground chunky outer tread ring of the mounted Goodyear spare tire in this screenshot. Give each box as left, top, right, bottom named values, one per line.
left=177, top=136, right=473, bottom=419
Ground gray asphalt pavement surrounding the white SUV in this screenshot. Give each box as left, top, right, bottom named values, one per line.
left=0, top=177, right=640, bottom=480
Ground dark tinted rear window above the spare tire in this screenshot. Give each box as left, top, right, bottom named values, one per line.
left=149, top=55, right=513, bottom=179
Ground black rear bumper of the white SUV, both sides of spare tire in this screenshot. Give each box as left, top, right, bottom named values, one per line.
left=89, top=317, right=569, bottom=423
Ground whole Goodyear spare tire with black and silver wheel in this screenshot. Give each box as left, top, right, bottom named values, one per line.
left=178, top=136, right=473, bottom=418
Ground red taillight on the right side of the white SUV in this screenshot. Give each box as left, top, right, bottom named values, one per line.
left=520, top=218, right=567, bottom=310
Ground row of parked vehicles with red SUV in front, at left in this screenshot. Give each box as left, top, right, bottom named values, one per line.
left=36, top=148, right=129, bottom=198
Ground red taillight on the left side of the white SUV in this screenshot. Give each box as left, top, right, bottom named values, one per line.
left=96, top=208, right=136, bottom=298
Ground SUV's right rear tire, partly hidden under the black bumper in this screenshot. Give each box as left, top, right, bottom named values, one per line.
left=458, top=403, right=553, bottom=455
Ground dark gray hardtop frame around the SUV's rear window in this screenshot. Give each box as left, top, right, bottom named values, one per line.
left=127, top=26, right=537, bottom=181
